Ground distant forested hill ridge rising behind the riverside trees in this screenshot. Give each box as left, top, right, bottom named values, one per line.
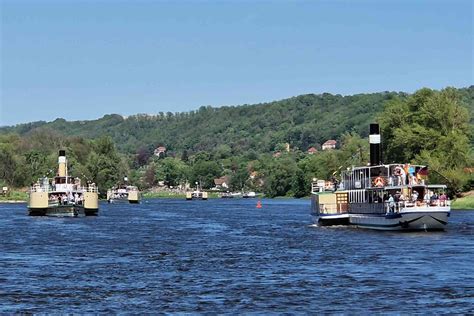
left=0, top=86, right=474, bottom=153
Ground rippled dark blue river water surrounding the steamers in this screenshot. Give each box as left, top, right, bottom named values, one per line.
left=0, top=199, right=474, bottom=313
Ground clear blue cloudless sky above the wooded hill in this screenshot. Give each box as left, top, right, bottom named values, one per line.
left=0, top=0, right=474, bottom=125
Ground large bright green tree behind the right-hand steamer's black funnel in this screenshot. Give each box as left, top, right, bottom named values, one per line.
left=379, top=88, right=473, bottom=191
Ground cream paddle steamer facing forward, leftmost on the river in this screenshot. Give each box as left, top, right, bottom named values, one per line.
left=28, top=150, right=99, bottom=217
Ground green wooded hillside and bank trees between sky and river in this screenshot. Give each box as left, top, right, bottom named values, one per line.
left=0, top=86, right=474, bottom=202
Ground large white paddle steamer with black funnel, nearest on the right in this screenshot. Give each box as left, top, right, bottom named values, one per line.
left=312, top=124, right=451, bottom=230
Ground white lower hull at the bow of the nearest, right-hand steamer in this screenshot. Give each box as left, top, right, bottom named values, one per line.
left=349, top=207, right=450, bottom=230
